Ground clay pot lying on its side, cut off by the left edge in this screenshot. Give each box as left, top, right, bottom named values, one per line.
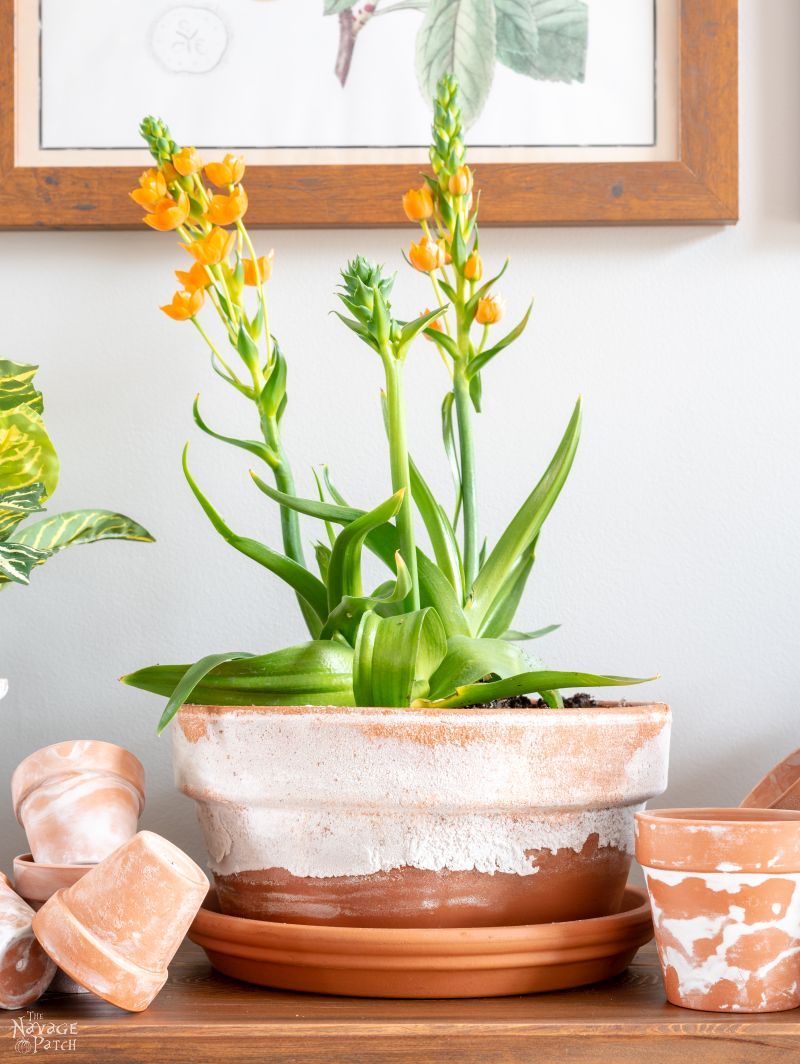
left=0, top=872, right=55, bottom=1009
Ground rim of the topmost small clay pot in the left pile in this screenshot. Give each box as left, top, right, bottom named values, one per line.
left=11, top=738, right=145, bottom=824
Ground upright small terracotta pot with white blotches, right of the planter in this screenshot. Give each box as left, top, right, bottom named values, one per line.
left=636, top=809, right=800, bottom=1012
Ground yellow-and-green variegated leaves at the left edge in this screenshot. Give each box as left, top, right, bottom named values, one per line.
left=0, top=360, right=153, bottom=698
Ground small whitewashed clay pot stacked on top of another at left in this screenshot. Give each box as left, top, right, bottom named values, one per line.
left=11, top=739, right=145, bottom=865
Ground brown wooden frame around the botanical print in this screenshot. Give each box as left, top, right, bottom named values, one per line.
left=0, top=0, right=738, bottom=230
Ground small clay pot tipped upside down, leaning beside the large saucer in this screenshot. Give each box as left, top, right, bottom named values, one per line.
left=33, top=831, right=209, bottom=1012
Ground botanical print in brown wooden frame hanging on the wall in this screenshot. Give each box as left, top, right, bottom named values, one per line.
left=0, top=0, right=737, bottom=228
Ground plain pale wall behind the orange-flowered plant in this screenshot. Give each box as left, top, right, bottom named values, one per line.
left=0, top=0, right=800, bottom=868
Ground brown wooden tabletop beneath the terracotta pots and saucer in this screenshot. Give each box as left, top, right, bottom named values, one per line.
left=0, top=943, right=800, bottom=1064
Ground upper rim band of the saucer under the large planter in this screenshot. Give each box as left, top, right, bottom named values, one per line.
left=189, top=884, right=650, bottom=957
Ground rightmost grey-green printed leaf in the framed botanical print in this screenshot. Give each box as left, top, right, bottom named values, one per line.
left=495, top=0, right=588, bottom=82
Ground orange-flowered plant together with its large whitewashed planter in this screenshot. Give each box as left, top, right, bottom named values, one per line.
left=123, top=77, right=669, bottom=927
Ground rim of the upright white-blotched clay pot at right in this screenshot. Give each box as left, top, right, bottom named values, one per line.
left=636, top=807, right=800, bottom=876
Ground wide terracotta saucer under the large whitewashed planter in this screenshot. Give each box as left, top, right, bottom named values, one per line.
left=188, top=886, right=653, bottom=998
